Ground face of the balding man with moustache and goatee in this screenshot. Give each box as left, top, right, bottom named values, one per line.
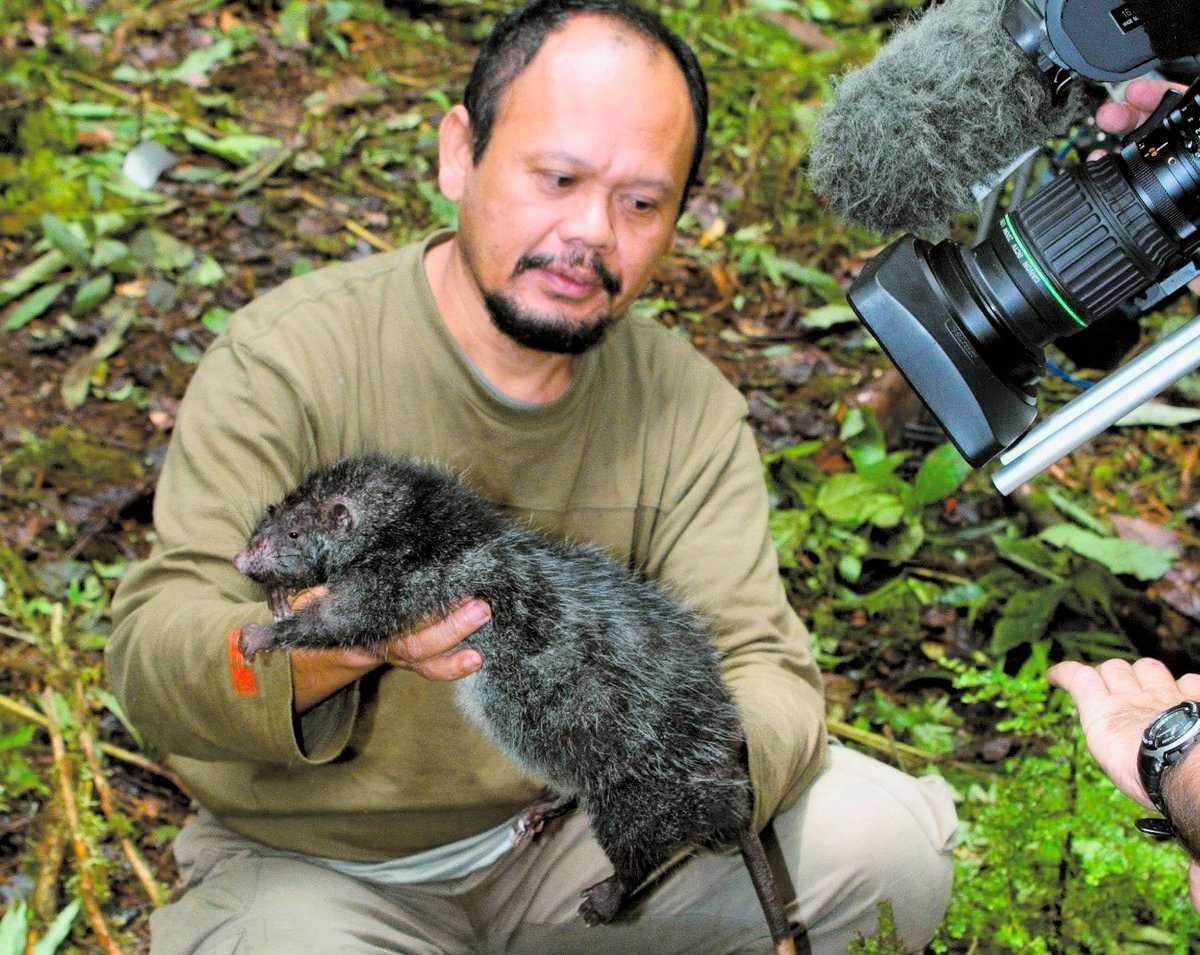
left=443, top=16, right=695, bottom=353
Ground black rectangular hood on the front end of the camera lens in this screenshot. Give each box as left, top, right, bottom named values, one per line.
left=848, top=235, right=1037, bottom=467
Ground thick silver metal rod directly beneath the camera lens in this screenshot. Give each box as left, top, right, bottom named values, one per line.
left=991, top=318, right=1200, bottom=494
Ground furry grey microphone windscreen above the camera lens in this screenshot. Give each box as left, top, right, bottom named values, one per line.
left=809, top=0, right=1086, bottom=239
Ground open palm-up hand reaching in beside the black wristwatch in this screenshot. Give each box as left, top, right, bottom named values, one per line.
left=1049, top=659, right=1200, bottom=811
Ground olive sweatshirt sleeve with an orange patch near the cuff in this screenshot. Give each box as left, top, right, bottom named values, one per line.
left=106, top=338, right=359, bottom=764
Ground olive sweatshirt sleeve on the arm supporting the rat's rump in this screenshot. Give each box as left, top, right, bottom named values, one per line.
left=647, top=415, right=826, bottom=829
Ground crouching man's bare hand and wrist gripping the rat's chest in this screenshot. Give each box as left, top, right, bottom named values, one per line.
left=292, top=587, right=492, bottom=713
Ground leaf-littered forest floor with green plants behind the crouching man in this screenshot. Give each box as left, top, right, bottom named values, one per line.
left=7, top=0, right=1200, bottom=955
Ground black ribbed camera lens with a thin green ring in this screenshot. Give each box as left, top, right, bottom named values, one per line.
left=850, top=82, right=1200, bottom=466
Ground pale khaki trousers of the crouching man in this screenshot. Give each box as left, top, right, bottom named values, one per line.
left=150, top=746, right=955, bottom=955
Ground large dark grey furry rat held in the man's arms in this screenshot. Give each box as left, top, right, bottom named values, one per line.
left=234, top=455, right=794, bottom=954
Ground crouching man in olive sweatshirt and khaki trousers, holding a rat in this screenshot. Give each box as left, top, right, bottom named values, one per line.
left=108, top=0, right=955, bottom=953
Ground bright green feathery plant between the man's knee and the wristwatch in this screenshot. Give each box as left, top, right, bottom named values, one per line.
left=934, top=642, right=1200, bottom=955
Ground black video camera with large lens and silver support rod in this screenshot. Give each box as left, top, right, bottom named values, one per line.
left=848, top=0, right=1200, bottom=493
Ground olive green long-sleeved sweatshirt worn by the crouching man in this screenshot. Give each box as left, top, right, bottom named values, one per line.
left=107, top=234, right=824, bottom=861
